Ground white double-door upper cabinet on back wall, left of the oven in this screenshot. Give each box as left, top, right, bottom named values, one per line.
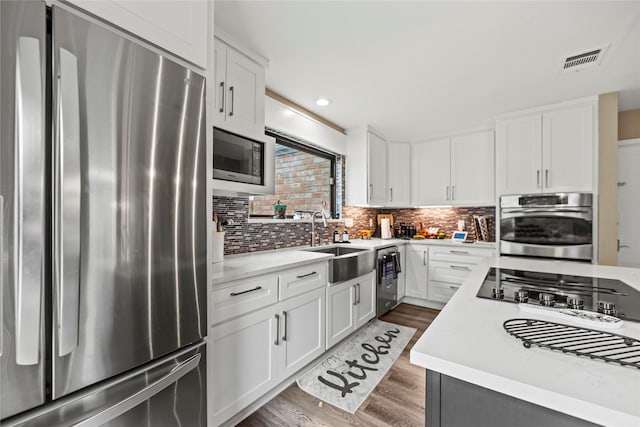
left=411, top=131, right=495, bottom=206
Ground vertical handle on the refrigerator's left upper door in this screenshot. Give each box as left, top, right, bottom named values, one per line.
left=12, top=37, right=44, bottom=365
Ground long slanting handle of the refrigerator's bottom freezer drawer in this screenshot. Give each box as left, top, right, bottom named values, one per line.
left=74, top=353, right=201, bottom=427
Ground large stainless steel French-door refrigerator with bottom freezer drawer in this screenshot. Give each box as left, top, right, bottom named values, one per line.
left=0, top=0, right=207, bottom=427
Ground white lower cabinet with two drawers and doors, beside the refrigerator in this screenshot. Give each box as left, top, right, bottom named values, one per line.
left=208, top=264, right=327, bottom=425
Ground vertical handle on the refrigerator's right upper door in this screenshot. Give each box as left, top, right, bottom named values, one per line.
left=54, top=48, right=81, bottom=357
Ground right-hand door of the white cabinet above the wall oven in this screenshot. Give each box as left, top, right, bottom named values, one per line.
left=542, top=105, right=594, bottom=192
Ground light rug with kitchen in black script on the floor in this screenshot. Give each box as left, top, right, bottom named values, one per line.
left=297, top=319, right=416, bottom=414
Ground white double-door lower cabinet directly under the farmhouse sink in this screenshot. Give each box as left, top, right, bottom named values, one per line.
left=326, top=271, right=376, bottom=349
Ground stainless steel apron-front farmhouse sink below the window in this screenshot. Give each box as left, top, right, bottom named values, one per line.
left=304, top=246, right=375, bottom=283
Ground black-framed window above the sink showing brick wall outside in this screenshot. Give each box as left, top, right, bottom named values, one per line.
left=249, top=132, right=340, bottom=218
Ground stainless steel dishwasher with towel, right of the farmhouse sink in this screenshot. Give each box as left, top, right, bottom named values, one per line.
left=376, top=246, right=400, bottom=317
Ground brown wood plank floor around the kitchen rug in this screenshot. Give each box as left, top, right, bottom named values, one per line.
left=238, top=304, right=438, bottom=427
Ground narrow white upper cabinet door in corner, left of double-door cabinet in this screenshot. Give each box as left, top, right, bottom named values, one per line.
left=387, top=142, right=411, bottom=207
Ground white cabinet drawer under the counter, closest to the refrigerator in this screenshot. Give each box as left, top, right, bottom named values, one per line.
left=210, top=274, right=278, bottom=325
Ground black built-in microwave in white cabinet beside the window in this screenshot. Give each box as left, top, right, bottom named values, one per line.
left=213, top=127, right=265, bottom=185
